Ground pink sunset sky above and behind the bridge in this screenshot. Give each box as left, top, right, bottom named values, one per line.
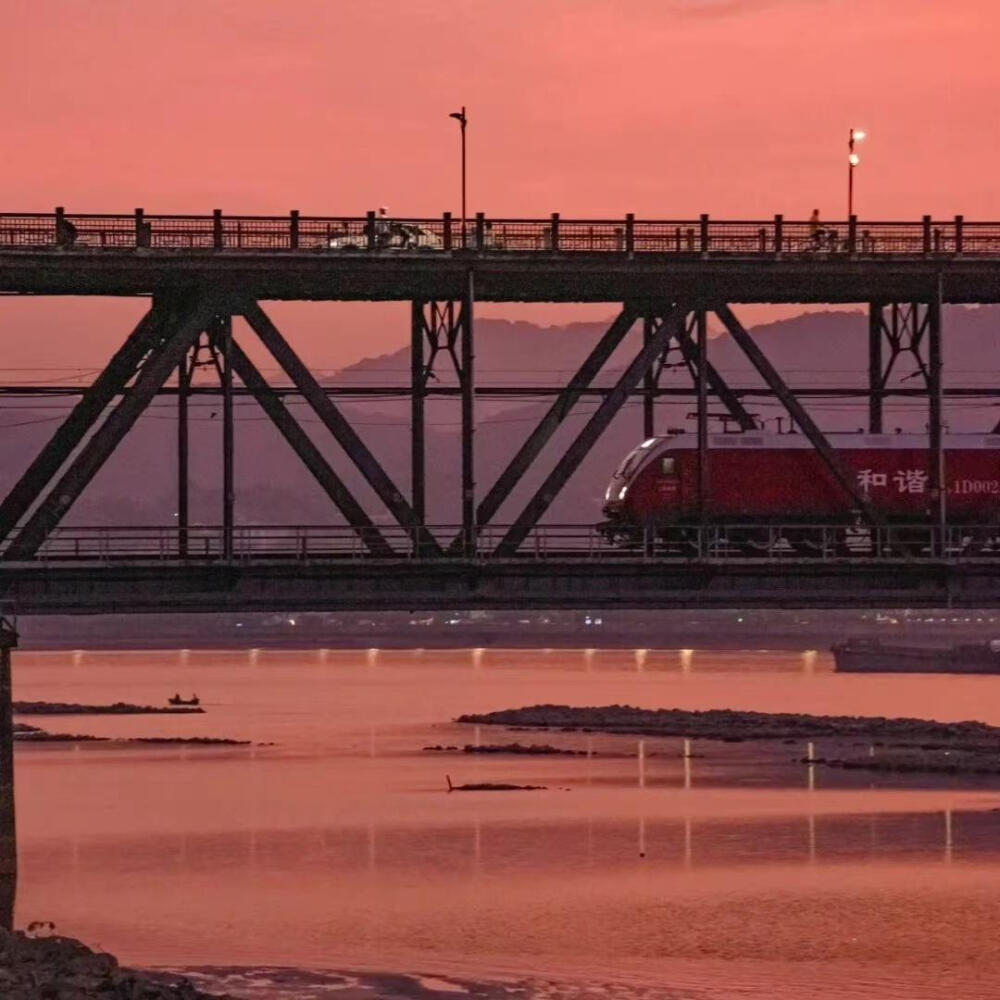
left=0, top=0, right=1000, bottom=367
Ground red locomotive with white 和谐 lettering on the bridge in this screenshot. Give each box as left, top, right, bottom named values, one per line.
left=602, top=431, right=1000, bottom=543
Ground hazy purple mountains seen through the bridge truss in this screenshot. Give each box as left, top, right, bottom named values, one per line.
left=0, top=307, right=1000, bottom=526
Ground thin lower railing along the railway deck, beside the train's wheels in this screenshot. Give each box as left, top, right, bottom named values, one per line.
left=11, top=524, right=1000, bottom=563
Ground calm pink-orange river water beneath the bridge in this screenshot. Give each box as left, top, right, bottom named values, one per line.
left=14, top=650, right=1000, bottom=1000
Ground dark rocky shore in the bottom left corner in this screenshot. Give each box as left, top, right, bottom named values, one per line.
left=0, top=930, right=228, bottom=1000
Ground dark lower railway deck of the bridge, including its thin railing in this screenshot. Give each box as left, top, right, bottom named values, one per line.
left=0, top=526, right=1000, bottom=614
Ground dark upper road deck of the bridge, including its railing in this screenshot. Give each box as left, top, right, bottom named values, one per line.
left=0, top=212, right=1000, bottom=303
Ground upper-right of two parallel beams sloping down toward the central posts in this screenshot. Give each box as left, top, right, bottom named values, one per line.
left=240, top=301, right=439, bottom=551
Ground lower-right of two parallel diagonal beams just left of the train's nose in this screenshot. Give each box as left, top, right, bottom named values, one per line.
left=496, top=307, right=677, bottom=555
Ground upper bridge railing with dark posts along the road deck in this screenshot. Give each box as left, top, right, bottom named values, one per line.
left=0, top=208, right=1000, bottom=258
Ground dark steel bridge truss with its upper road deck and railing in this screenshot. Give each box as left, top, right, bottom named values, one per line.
left=0, top=209, right=1000, bottom=611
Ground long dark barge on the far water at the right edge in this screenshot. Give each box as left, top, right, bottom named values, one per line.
left=830, top=639, right=1000, bottom=674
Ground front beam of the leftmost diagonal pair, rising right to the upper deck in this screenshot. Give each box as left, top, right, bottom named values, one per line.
left=4, top=299, right=211, bottom=560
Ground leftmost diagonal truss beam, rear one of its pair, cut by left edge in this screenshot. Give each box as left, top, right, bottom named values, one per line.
left=0, top=309, right=160, bottom=541
